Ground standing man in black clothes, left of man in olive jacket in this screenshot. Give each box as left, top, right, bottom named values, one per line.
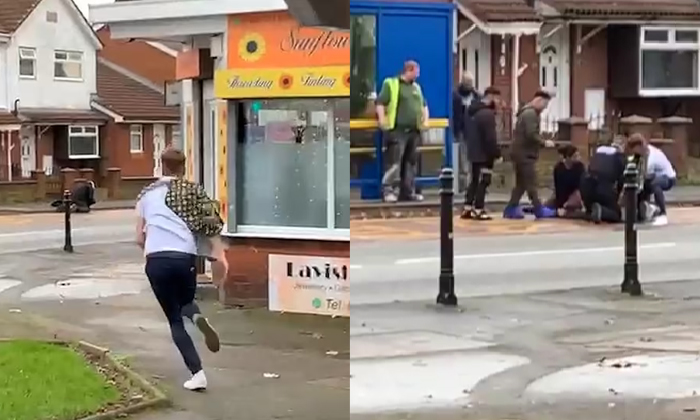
left=461, top=87, right=501, bottom=220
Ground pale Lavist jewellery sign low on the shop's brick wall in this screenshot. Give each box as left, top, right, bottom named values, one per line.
left=268, top=254, right=350, bottom=317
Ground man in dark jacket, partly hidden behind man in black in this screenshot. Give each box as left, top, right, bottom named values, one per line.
left=452, top=72, right=481, bottom=185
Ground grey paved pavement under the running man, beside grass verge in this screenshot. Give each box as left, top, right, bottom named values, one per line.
left=0, top=244, right=349, bottom=420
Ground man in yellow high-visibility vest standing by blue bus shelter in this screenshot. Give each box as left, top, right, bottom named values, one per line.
left=376, top=61, right=428, bottom=203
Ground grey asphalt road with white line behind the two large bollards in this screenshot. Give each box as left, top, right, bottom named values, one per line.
left=351, top=220, right=700, bottom=308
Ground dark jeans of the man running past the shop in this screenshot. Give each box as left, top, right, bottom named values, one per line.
left=146, top=252, right=202, bottom=374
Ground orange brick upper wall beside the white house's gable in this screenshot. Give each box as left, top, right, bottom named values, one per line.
left=97, top=26, right=175, bottom=86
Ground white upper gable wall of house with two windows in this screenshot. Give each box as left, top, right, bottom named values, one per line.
left=9, top=0, right=96, bottom=109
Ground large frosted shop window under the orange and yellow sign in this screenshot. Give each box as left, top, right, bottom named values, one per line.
left=234, top=99, right=350, bottom=236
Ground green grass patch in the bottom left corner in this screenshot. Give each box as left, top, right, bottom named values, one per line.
left=0, top=341, right=123, bottom=420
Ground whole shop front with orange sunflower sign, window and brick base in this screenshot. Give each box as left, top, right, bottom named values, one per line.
left=214, top=11, right=350, bottom=315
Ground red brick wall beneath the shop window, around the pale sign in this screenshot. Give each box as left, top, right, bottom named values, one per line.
left=223, top=238, right=350, bottom=306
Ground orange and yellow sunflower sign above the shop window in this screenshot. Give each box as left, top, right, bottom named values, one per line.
left=214, top=12, right=350, bottom=99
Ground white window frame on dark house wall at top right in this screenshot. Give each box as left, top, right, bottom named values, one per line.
left=638, top=26, right=700, bottom=97
